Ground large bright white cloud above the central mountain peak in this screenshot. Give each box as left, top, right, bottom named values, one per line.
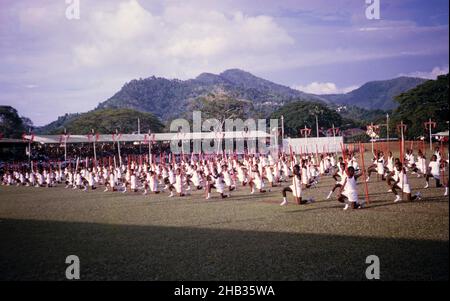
left=73, top=0, right=294, bottom=78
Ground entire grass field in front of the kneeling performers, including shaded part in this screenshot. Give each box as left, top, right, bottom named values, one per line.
left=0, top=154, right=449, bottom=280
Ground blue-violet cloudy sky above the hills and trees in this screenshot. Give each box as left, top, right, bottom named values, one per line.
left=0, top=0, right=449, bottom=126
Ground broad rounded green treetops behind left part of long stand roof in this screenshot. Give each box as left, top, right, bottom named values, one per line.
left=36, top=109, right=164, bottom=135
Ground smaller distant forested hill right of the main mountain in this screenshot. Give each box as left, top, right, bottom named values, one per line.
left=321, top=77, right=426, bottom=110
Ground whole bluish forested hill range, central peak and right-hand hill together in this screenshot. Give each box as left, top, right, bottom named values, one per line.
left=98, top=69, right=425, bottom=121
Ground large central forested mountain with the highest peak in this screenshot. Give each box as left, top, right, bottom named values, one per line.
left=97, top=69, right=326, bottom=121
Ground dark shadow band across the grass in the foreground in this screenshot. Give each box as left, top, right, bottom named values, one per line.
left=0, top=219, right=449, bottom=280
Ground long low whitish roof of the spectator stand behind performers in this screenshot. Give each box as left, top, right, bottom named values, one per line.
left=23, top=131, right=273, bottom=144
